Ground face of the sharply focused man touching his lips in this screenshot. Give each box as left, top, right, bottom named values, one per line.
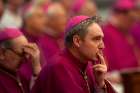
left=79, top=23, right=104, bottom=60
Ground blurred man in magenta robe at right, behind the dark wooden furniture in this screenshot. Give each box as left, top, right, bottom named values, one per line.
left=103, top=0, right=139, bottom=71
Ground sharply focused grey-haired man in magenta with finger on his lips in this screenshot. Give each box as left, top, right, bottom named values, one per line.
left=31, top=16, right=115, bottom=93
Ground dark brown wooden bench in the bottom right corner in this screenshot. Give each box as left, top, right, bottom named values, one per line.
left=121, top=69, right=140, bottom=93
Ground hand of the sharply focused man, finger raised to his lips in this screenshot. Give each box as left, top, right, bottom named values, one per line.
left=93, top=53, right=107, bottom=88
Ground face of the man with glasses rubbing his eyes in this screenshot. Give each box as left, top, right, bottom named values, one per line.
left=1, top=36, right=28, bottom=71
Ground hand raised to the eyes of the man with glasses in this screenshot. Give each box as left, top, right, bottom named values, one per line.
left=23, top=43, right=41, bottom=75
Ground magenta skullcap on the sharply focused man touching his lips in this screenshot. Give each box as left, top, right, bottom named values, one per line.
left=66, top=15, right=90, bottom=31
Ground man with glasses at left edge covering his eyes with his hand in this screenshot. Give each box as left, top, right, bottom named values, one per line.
left=0, top=28, right=41, bottom=93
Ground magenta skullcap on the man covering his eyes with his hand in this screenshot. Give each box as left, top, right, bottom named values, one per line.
left=0, top=27, right=23, bottom=43
